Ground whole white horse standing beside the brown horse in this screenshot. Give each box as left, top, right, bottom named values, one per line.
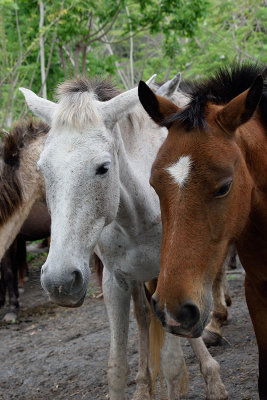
left=22, top=77, right=227, bottom=400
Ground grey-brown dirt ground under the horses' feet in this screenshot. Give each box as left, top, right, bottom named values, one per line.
left=0, top=255, right=258, bottom=400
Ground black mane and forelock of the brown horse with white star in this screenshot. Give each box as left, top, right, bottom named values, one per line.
left=168, top=63, right=267, bottom=130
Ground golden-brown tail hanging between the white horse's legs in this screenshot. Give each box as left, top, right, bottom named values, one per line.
left=145, top=279, right=189, bottom=398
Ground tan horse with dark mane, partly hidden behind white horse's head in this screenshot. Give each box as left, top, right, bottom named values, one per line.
left=0, top=120, right=49, bottom=260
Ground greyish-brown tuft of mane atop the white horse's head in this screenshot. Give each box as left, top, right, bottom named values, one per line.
left=57, top=77, right=121, bottom=101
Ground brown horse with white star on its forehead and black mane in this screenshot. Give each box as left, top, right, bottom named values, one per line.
left=139, top=64, right=267, bottom=400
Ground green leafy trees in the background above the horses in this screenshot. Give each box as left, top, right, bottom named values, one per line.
left=0, top=0, right=267, bottom=128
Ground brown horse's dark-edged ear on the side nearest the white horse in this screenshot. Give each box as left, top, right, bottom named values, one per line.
left=138, top=81, right=179, bottom=126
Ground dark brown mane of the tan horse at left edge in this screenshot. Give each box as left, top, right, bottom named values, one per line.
left=0, top=120, right=49, bottom=225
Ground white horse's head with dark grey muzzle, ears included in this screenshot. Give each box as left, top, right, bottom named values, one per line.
left=21, top=74, right=182, bottom=307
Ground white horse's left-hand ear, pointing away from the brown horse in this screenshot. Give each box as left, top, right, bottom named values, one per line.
left=19, top=88, right=57, bottom=126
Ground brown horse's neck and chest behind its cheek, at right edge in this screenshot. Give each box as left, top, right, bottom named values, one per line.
left=237, top=111, right=267, bottom=280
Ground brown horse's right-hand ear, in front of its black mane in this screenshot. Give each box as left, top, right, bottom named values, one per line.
left=216, top=75, right=263, bottom=134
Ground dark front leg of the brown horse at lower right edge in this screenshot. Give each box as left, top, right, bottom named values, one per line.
left=245, top=276, right=267, bottom=400
